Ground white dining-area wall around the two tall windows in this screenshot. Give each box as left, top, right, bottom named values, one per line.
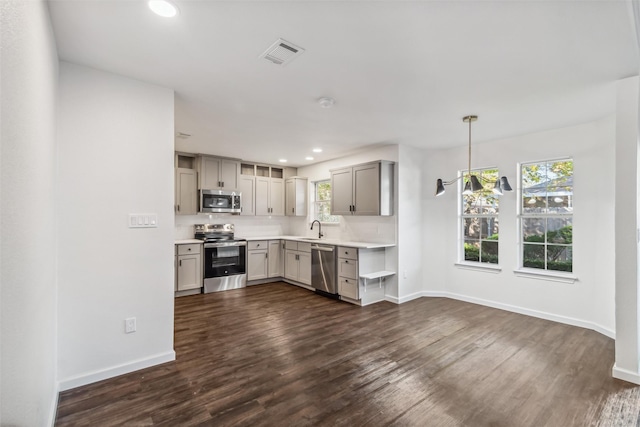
left=423, top=117, right=616, bottom=336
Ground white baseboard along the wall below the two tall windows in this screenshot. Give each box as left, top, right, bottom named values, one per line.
left=396, top=291, right=616, bottom=340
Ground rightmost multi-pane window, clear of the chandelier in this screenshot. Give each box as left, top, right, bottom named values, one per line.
left=520, top=159, right=573, bottom=272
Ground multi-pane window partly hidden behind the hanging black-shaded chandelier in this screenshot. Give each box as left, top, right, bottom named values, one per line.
left=460, top=169, right=499, bottom=264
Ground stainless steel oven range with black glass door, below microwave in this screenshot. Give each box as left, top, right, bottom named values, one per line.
left=194, top=224, right=247, bottom=294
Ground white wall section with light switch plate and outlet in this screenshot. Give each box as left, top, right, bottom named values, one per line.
left=58, top=62, right=175, bottom=389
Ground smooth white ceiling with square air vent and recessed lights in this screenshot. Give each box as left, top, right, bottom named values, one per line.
left=50, top=0, right=639, bottom=166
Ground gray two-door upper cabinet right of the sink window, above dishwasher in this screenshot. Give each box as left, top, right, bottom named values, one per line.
left=331, top=160, right=394, bottom=216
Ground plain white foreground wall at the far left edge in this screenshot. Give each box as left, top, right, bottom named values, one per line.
left=0, top=1, right=58, bottom=426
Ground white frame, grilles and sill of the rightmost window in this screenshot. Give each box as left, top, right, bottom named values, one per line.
left=514, top=156, right=577, bottom=283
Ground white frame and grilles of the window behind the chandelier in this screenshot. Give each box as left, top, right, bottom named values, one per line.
left=456, top=166, right=501, bottom=271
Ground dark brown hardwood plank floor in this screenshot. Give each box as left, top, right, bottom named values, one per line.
left=56, top=283, right=631, bottom=427
